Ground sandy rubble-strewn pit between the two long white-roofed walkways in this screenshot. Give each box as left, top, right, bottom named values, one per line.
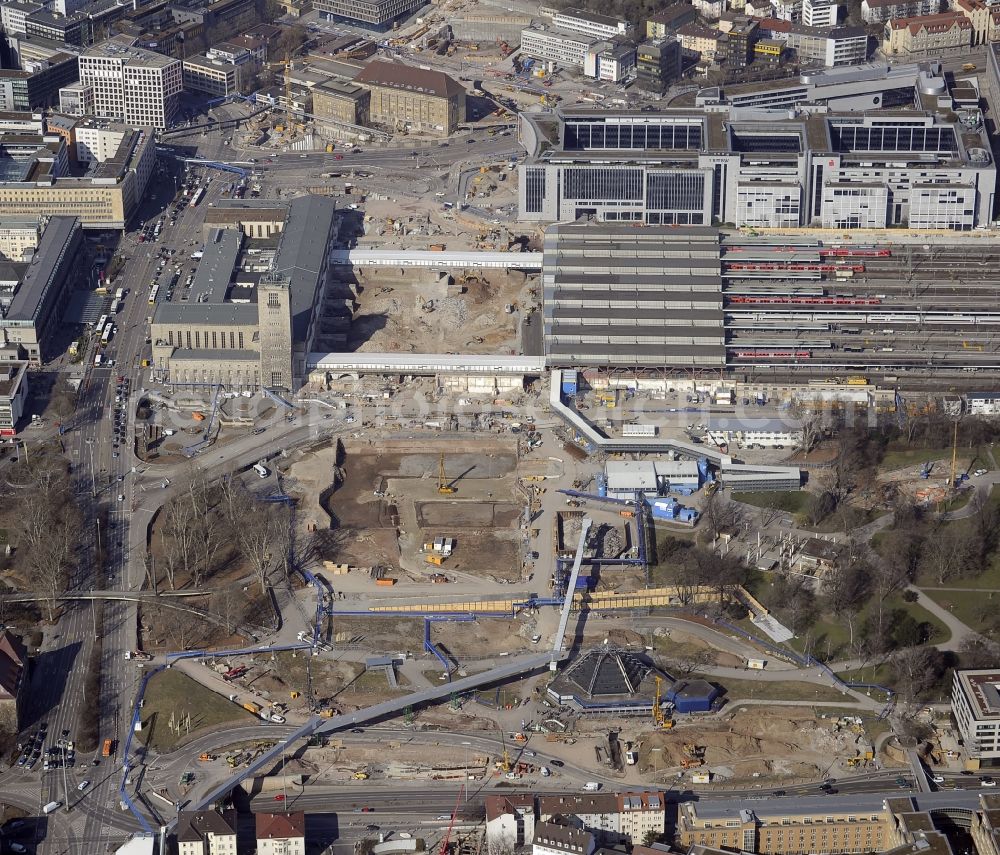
left=348, top=267, right=537, bottom=354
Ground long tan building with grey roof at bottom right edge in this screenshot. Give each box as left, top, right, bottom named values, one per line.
left=676, top=795, right=900, bottom=855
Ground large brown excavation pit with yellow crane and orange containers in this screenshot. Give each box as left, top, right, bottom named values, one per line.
left=288, top=439, right=521, bottom=584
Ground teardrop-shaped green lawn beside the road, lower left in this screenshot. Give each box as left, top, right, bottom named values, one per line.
left=139, top=669, right=259, bottom=754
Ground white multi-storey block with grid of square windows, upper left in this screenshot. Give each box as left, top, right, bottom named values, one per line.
left=80, top=35, right=184, bottom=128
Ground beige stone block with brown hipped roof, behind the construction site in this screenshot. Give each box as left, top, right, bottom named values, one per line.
left=354, top=60, right=465, bottom=136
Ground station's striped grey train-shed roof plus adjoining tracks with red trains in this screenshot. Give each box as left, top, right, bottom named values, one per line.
left=542, top=223, right=1000, bottom=384
